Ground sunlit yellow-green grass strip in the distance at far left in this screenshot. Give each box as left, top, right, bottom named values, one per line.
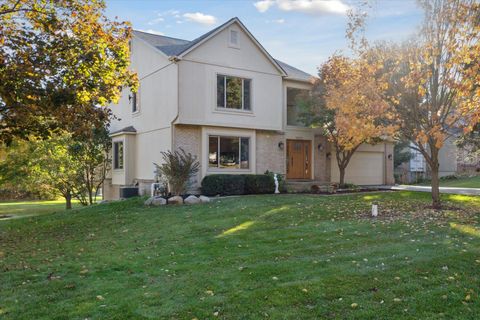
left=0, top=199, right=78, bottom=221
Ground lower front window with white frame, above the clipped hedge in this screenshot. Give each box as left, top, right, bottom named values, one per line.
left=208, top=136, right=250, bottom=169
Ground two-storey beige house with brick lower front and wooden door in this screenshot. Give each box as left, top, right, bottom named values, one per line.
left=104, top=18, right=393, bottom=199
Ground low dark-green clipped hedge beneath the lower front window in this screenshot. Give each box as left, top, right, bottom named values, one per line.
left=202, top=174, right=275, bottom=196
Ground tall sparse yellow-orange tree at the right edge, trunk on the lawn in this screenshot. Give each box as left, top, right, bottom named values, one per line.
left=372, top=0, right=480, bottom=208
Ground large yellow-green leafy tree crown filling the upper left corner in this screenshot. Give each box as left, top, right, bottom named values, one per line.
left=0, top=0, right=137, bottom=142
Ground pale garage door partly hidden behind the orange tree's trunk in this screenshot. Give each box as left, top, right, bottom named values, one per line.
left=332, top=151, right=384, bottom=185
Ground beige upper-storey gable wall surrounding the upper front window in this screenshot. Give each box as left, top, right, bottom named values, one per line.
left=177, top=25, right=283, bottom=130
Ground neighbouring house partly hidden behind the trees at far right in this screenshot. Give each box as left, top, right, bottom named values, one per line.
left=395, top=138, right=458, bottom=183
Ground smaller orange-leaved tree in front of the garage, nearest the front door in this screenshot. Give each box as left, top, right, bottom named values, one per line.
left=300, top=55, right=395, bottom=186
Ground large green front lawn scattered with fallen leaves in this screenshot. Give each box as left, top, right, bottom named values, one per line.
left=0, top=192, right=480, bottom=319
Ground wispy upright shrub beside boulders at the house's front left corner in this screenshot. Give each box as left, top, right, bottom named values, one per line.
left=155, top=148, right=200, bottom=195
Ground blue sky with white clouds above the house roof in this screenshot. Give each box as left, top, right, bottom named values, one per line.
left=106, top=0, right=423, bottom=75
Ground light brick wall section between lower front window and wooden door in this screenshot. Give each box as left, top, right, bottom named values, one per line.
left=256, top=131, right=286, bottom=174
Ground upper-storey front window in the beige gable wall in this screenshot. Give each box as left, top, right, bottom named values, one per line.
left=217, top=74, right=252, bottom=111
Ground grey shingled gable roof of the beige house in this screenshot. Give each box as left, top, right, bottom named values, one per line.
left=133, top=17, right=312, bottom=81
